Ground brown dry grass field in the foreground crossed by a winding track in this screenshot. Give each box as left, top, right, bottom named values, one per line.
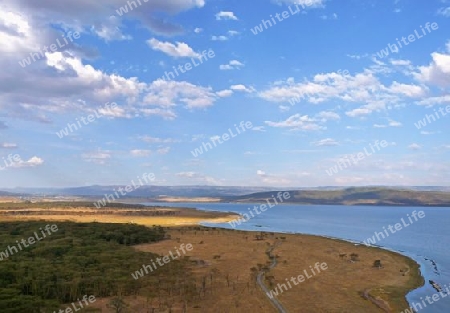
left=129, top=228, right=423, bottom=313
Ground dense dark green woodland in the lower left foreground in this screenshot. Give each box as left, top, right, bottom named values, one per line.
left=0, top=221, right=193, bottom=313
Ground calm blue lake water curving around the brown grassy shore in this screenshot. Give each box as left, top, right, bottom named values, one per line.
left=145, top=203, right=450, bottom=313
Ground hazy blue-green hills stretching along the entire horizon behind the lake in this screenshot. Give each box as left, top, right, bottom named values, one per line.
left=0, top=186, right=450, bottom=207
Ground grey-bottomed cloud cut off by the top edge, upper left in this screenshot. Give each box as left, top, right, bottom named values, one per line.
left=2, top=0, right=205, bottom=40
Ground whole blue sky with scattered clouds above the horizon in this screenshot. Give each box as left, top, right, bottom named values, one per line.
left=0, top=0, right=450, bottom=188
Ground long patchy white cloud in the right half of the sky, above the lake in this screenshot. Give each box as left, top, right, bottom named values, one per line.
left=258, top=65, right=428, bottom=117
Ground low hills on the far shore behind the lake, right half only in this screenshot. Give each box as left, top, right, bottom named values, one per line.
left=222, top=187, right=450, bottom=207
